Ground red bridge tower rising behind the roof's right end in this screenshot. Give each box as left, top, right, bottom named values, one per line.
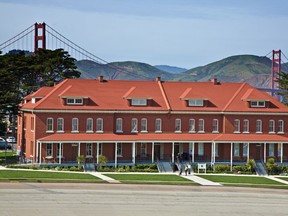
left=271, top=50, right=281, bottom=96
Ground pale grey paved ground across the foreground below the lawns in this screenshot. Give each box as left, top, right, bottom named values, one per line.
left=0, top=183, right=288, bottom=216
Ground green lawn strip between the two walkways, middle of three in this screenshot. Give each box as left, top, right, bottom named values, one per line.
left=105, top=174, right=198, bottom=185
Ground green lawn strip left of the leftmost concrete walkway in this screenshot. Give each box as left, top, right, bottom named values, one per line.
left=0, top=170, right=103, bottom=182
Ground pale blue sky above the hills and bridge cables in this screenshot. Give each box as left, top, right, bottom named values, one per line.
left=0, top=0, right=288, bottom=69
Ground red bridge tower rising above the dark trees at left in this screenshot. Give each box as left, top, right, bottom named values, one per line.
left=34, top=23, right=46, bottom=54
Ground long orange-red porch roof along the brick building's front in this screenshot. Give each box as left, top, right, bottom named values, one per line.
left=38, top=133, right=288, bottom=143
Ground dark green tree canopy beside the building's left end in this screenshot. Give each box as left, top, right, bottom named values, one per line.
left=0, top=49, right=81, bottom=118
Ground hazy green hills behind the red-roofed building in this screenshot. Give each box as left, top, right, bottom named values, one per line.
left=76, top=55, right=288, bottom=88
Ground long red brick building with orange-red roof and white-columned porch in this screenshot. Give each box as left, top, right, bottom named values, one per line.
left=17, top=77, right=288, bottom=166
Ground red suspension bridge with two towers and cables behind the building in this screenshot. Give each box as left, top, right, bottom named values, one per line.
left=0, top=23, right=288, bottom=95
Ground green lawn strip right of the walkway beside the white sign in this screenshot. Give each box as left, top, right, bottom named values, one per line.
left=197, top=175, right=288, bottom=189
